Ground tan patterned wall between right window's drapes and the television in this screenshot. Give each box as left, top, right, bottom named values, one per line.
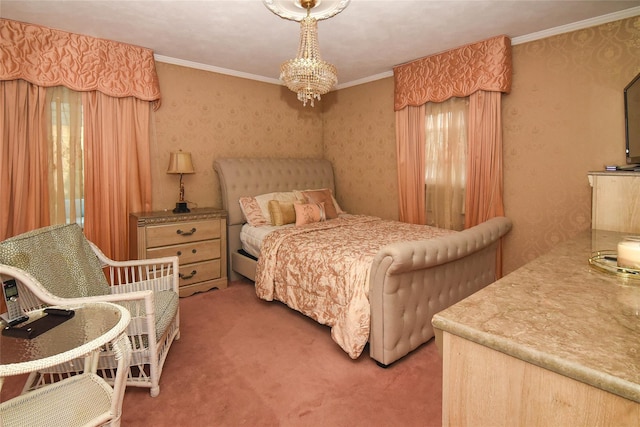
left=503, top=17, right=640, bottom=271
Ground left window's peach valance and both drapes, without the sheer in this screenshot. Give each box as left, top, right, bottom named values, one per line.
left=0, top=19, right=160, bottom=260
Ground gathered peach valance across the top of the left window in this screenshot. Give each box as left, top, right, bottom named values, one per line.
left=0, top=19, right=160, bottom=104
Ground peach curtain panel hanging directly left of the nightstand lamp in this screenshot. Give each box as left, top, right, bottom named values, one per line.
left=82, top=91, right=151, bottom=260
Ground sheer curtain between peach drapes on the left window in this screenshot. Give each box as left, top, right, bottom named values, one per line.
left=46, top=86, right=84, bottom=226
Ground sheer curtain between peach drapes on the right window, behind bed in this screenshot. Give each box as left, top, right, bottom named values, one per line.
left=425, top=98, right=469, bottom=230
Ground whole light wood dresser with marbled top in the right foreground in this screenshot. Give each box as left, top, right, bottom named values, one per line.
left=432, top=230, right=640, bottom=427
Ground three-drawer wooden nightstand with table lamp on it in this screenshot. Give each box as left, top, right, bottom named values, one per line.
left=129, top=208, right=227, bottom=297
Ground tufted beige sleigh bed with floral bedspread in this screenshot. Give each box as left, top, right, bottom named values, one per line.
left=214, top=158, right=511, bottom=366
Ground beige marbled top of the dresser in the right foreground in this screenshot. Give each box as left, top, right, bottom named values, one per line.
left=433, top=230, right=640, bottom=403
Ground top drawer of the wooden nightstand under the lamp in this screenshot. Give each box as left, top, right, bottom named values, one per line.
left=146, top=221, right=220, bottom=248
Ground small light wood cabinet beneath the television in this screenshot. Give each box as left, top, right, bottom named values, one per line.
left=588, top=171, right=640, bottom=233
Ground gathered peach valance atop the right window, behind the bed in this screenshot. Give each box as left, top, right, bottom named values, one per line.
left=393, top=36, right=512, bottom=111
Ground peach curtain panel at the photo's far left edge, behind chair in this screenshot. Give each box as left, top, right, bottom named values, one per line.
left=0, top=80, right=49, bottom=240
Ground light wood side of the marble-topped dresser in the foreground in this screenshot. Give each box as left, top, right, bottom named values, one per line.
left=442, top=331, right=640, bottom=427
